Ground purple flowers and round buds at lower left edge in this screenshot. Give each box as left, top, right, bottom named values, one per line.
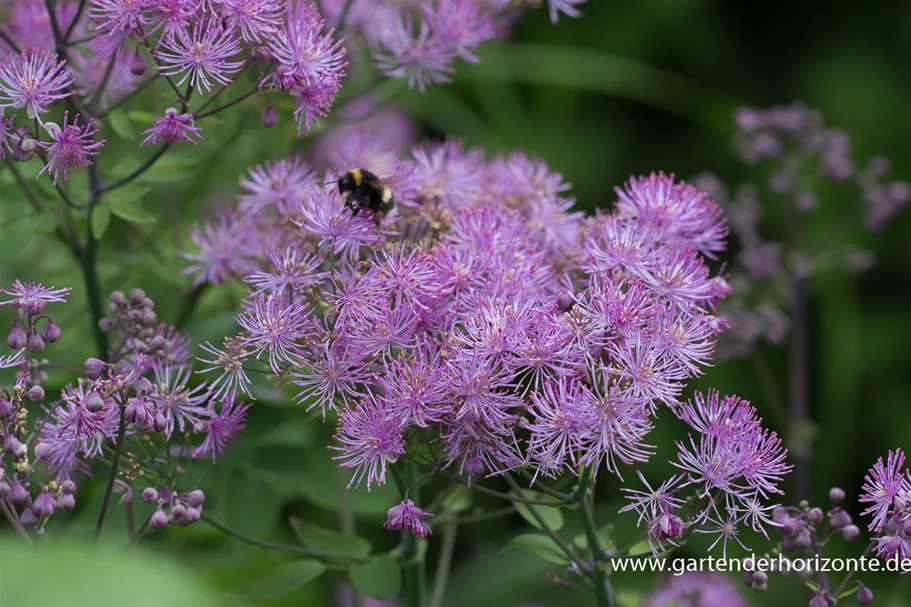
left=0, top=281, right=248, bottom=532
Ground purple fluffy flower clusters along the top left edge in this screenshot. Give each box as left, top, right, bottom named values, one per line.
left=0, top=0, right=581, bottom=185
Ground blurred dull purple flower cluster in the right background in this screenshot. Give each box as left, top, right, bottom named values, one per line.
left=695, top=103, right=911, bottom=357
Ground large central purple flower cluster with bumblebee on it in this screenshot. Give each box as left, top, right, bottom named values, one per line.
left=180, top=133, right=788, bottom=552
